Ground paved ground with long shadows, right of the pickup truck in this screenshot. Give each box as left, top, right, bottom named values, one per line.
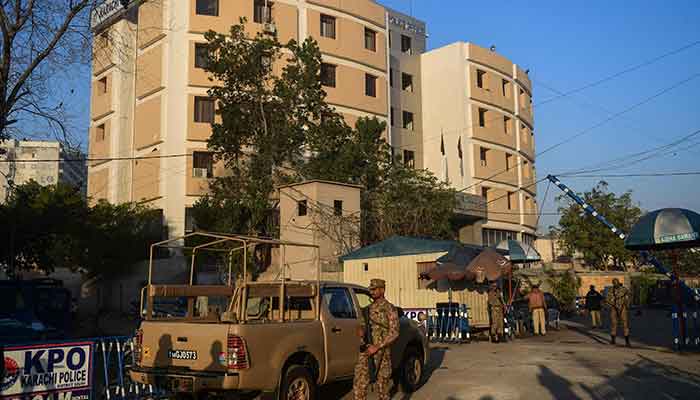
left=321, top=312, right=700, bottom=400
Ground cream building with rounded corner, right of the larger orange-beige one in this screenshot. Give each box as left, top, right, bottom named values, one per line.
left=421, top=42, right=537, bottom=245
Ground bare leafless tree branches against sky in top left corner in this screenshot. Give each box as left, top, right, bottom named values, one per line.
left=0, top=0, right=95, bottom=141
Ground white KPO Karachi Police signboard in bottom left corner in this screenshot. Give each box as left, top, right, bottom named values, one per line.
left=0, top=342, right=92, bottom=400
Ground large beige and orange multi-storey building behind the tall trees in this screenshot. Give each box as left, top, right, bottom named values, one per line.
left=88, top=0, right=425, bottom=235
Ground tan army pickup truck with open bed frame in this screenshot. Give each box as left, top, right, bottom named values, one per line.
left=129, top=280, right=429, bottom=400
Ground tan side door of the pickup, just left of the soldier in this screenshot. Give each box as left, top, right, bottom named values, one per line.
left=322, top=287, right=360, bottom=379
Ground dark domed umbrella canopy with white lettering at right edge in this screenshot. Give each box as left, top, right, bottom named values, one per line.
left=625, top=208, right=700, bottom=250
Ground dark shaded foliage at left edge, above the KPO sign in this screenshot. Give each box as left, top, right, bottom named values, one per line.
left=0, top=181, right=162, bottom=273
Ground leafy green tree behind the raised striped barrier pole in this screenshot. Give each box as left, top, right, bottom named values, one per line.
left=553, top=181, right=642, bottom=270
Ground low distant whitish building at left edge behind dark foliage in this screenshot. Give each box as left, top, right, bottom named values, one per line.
left=0, top=140, right=87, bottom=202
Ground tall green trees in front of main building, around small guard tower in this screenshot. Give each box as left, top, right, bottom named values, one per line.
left=194, top=20, right=456, bottom=248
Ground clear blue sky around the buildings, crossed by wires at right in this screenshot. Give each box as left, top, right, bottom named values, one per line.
left=35, top=0, right=700, bottom=232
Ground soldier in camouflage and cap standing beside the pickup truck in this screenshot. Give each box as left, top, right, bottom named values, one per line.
left=353, top=279, right=399, bottom=400
